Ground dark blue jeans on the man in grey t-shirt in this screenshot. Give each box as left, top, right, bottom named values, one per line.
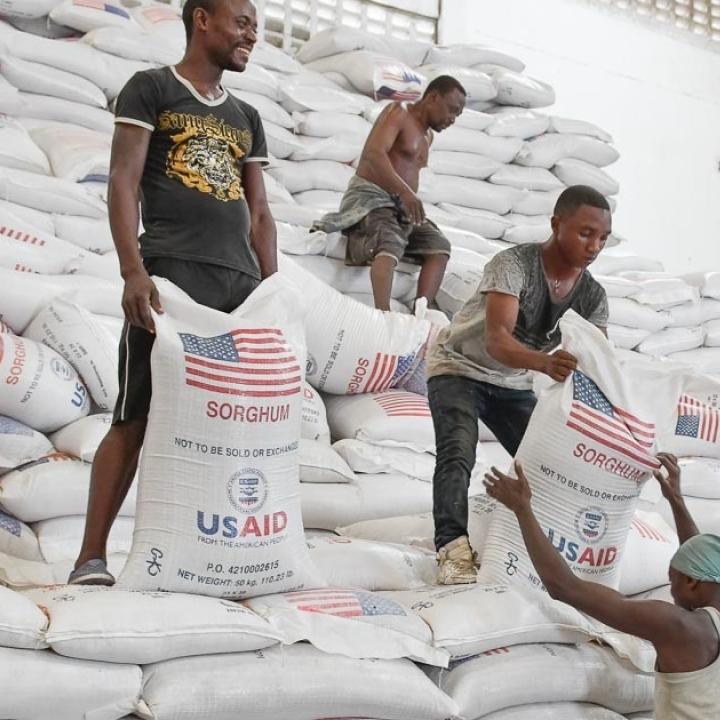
left=428, top=375, right=537, bottom=549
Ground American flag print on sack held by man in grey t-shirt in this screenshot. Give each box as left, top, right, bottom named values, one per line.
left=566, top=370, right=660, bottom=470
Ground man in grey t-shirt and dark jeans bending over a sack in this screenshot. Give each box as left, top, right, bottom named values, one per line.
left=428, top=185, right=611, bottom=585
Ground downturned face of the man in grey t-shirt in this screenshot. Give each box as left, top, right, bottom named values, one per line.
left=551, top=205, right=611, bottom=268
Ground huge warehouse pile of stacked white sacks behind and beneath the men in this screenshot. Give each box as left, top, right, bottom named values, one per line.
left=0, top=0, right=720, bottom=720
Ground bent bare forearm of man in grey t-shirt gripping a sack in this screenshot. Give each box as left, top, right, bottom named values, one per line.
left=485, top=292, right=577, bottom=382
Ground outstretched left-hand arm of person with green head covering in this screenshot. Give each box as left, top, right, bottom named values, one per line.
left=485, top=462, right=686, bottom=646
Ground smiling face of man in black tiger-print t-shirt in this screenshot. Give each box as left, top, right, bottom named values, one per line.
left=193, top=0, right=257, bottom=72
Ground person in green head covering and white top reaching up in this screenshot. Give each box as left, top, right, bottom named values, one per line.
left=485, top=453, right=720, bottom=720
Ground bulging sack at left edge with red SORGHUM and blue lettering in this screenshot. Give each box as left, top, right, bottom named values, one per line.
left=0, top=335, right=90, bottom=432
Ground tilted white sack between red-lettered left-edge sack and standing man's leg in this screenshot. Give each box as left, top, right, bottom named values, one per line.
left=25, top=298, right=118, bottom=410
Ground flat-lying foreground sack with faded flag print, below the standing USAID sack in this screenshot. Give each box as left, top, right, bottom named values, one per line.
left=246, top=586, right=449, bottom=667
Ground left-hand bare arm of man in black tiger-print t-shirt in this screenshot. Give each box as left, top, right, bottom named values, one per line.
left=108, top=123, right=162, bottom=332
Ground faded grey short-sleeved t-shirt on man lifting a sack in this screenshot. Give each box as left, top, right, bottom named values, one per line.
left=428, top=244, right=608, bottom=390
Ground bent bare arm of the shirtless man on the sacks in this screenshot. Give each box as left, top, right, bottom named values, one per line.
left=358, top=104, right=425, bottom=224
